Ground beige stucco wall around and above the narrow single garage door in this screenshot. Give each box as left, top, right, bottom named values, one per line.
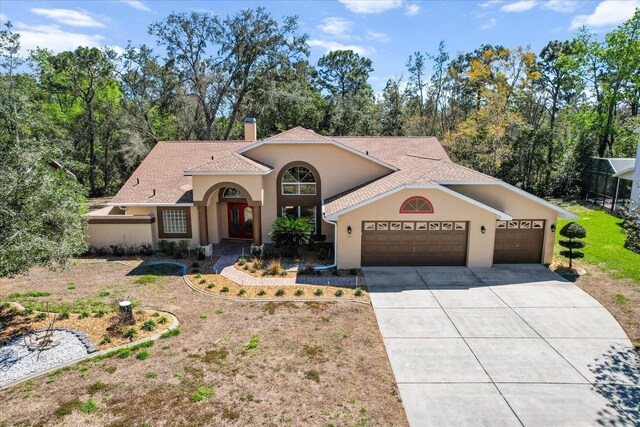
left=448, top=185, right=558, bottom=264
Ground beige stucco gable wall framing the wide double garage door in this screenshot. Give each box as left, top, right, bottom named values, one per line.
left=337, top=189, right=496, bottom=268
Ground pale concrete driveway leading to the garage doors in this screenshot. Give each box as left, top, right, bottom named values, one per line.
left=364, top=265, right=640, bottom=427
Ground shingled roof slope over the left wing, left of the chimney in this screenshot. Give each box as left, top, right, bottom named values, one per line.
left=111, top=141, right=249, bottom=204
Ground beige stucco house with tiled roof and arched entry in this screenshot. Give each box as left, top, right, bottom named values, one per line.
left=87, top=119, right=575, bottom=268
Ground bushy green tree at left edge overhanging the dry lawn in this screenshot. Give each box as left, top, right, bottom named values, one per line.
left=0, top=25, right=86, bottom=277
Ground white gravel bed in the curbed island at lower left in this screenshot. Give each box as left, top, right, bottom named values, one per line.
left=0, top=331, right=88, bottom=387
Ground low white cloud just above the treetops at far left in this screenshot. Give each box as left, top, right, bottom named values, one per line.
left=15, top=22, right=105, bottom=53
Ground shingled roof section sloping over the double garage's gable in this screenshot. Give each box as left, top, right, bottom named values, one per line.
left=324, top=156, right=498, bottom=216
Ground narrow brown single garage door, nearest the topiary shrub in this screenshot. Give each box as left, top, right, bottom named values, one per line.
left=493, top=219, right=545, bottom=264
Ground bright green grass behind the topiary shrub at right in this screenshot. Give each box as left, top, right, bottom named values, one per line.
left=554, top=203, right=640, bottom=286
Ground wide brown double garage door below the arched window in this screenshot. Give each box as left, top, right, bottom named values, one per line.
left=362, top=221, right=469, bottom=266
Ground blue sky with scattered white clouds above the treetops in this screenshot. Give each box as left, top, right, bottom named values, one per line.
left=0, top=0, right=640, bottom=91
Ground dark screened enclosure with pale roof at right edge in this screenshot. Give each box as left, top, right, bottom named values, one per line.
left=582, top=157, right=636, bottom=210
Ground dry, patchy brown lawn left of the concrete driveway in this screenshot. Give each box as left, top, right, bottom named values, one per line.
left=0, top=263, right=407, bottom=426
